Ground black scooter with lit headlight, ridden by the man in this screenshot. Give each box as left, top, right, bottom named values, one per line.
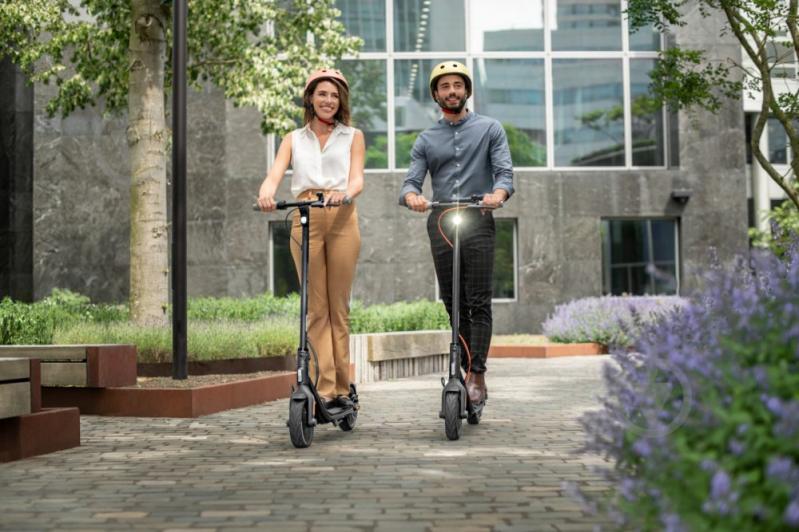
left=418, top=195, right=500, bottom=440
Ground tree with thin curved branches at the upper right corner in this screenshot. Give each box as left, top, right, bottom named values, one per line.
left=627, top=0, right=799, bottom=209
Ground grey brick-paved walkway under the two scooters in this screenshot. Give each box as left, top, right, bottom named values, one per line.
left=0, top=357, right=607, bottom=532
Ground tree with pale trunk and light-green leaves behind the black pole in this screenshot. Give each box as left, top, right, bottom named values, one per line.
left=0, top=0, right=360, bottom=323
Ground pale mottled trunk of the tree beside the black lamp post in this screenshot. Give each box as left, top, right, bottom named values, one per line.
left=128, top=0, right=169, bottom=325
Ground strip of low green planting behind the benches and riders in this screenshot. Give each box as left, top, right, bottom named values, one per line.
left=0, top=290, right=449, bottom=362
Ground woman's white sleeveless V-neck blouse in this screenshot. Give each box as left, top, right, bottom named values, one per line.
left=291, top=124, right=355, bottom=197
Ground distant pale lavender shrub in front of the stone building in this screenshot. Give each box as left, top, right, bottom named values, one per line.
left=543, top=296, right=686, bottom=347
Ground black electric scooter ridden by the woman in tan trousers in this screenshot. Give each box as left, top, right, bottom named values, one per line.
left=253, top=192, right=359, bottom=448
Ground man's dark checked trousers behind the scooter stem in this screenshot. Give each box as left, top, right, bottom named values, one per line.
left=427, top=208, right=496, bottom=373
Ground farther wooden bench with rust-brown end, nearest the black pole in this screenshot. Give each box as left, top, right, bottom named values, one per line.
left=0, top=345, right=136, bottom=388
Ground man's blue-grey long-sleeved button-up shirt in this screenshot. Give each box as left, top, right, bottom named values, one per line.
left=400, top=113, right=513, bottom=205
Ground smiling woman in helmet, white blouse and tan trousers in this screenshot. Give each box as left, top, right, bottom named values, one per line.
left=258, top=69, right=366, bottom=406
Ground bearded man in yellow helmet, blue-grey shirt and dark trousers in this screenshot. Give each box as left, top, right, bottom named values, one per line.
left=400, top=61, right=513, bottom=405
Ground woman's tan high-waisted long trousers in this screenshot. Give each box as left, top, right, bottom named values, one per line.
left=291, top=190, right=361, bottom=399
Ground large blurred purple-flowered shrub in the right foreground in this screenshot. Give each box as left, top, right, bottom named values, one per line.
left=582, top=247, right=799, bottom=531
